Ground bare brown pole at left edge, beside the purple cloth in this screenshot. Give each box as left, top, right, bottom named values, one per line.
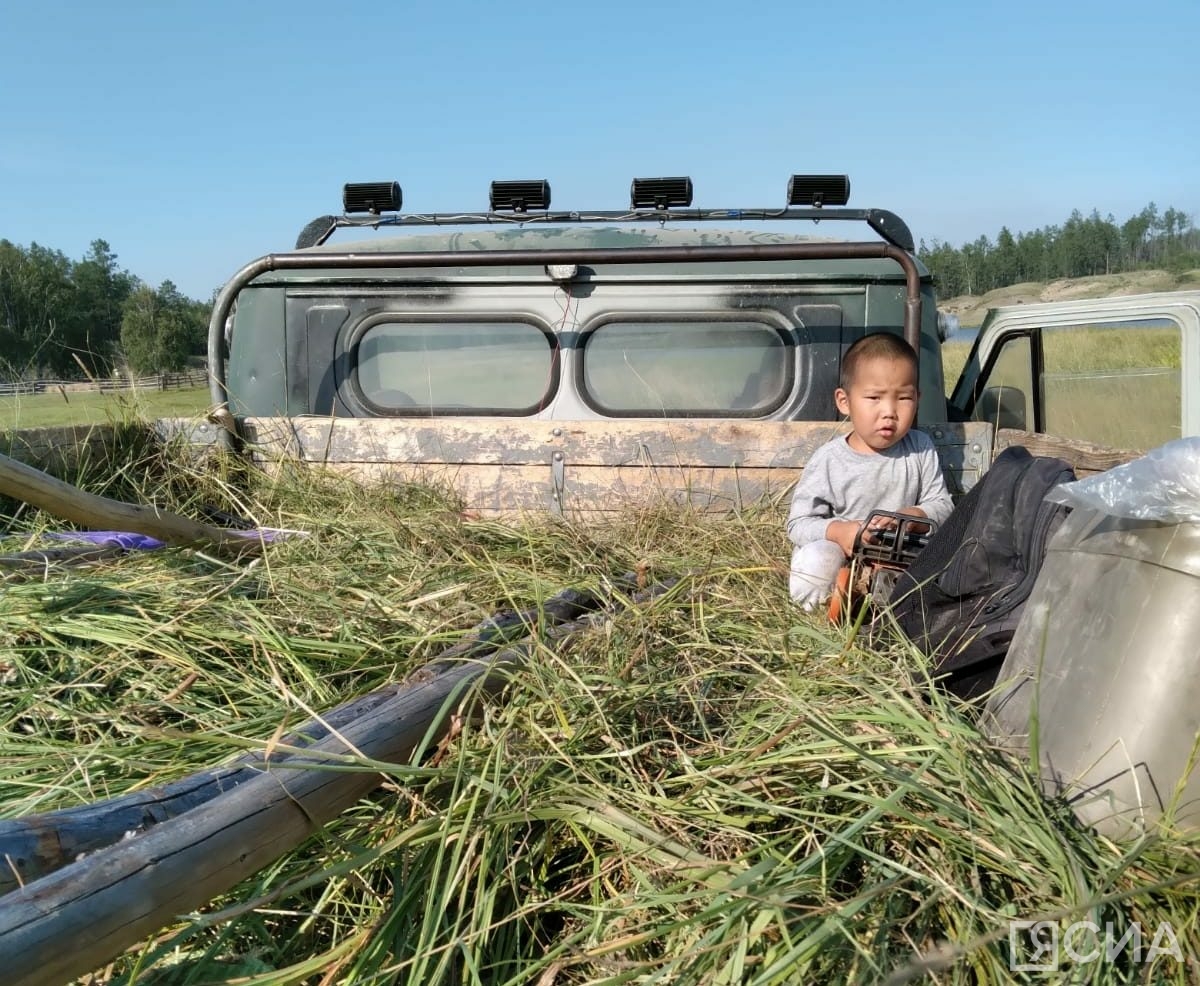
left=0, top=455, right=263, bottom=555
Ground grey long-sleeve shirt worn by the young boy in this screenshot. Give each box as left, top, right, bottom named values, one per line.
left=787, top=431, right=954, bottom=546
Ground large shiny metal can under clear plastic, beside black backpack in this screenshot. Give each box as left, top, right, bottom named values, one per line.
left=983, top=509, right=1200, bottom=838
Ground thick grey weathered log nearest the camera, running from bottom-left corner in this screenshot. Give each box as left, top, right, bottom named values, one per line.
left=0, top=583, right=672, bottom=986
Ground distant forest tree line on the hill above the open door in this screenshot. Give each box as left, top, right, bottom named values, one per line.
left=917, top=203, right=1200, bottom=297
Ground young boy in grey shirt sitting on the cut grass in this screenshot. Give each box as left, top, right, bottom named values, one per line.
left=787, top=332, right=953, bottom=612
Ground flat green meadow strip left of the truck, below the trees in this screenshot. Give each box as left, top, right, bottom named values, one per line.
left=0, top=387, right=209, bottom=431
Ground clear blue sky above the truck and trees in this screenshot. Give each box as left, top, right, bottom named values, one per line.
left=0, top=0, right=1200, bottom=297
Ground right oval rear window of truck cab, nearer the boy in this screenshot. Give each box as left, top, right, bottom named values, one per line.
left=576, top=318, right=793, bottom=417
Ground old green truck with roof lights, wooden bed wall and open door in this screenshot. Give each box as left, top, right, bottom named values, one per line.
left=209, top=175, right=1200, bottom=513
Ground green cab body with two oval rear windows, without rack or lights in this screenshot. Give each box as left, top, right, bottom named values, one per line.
left=228, top=228, right=943, bottom=421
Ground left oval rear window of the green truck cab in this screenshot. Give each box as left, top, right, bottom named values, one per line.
left=353, top=321, right=558, bottom=415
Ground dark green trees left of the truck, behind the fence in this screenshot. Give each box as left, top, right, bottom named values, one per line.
left=0, top=239, right=211, bottom=379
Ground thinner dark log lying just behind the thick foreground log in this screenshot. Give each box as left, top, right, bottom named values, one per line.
left=0, top=573, right=635, bottom=895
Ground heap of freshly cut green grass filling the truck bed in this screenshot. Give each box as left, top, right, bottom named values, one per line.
left=0, top=441, right=1200, bottom=986
